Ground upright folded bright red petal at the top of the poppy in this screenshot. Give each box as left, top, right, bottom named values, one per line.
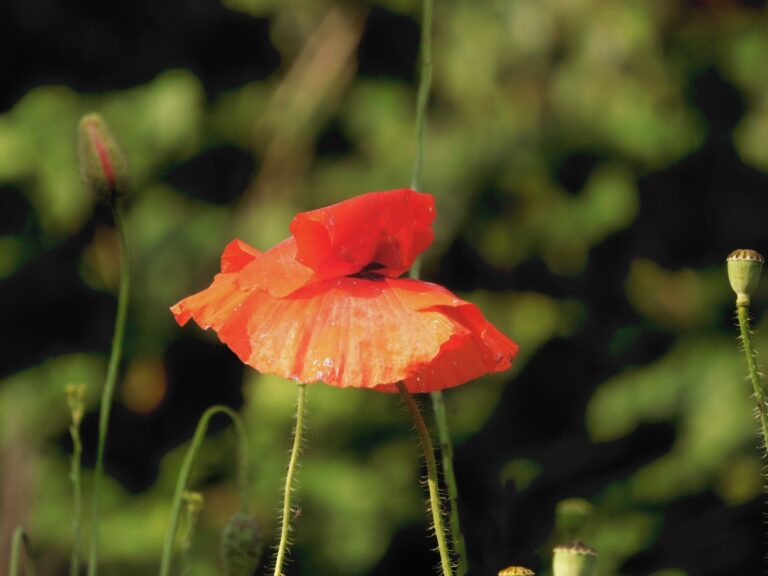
left=291, top=188, right=435, bottom=279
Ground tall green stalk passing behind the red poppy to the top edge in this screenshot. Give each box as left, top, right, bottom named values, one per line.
left=411, top=0, right=467, bottom=576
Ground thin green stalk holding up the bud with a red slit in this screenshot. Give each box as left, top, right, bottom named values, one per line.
left=88, top=198, right=131, bottom=576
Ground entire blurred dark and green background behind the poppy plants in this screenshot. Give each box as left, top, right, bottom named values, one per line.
left=0, top=0, right=768, bottom=576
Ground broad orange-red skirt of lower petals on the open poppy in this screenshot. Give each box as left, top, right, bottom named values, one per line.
left=173, top=268, right=517, bottom=392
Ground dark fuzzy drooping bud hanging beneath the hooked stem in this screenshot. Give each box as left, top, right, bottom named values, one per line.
left=221, top=513, right=264, bottom=576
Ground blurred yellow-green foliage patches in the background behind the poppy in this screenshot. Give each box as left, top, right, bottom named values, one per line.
left=0, top=0, right=768, bottom=576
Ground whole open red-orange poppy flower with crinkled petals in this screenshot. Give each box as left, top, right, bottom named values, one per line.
left=171, top=189, right=517, bottom=392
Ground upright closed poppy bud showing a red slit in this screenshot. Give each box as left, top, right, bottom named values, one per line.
left=77, top=114, right=128, bottom=201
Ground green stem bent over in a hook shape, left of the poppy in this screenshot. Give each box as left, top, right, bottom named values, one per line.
left=160, top=406, right=247, bottom=576
